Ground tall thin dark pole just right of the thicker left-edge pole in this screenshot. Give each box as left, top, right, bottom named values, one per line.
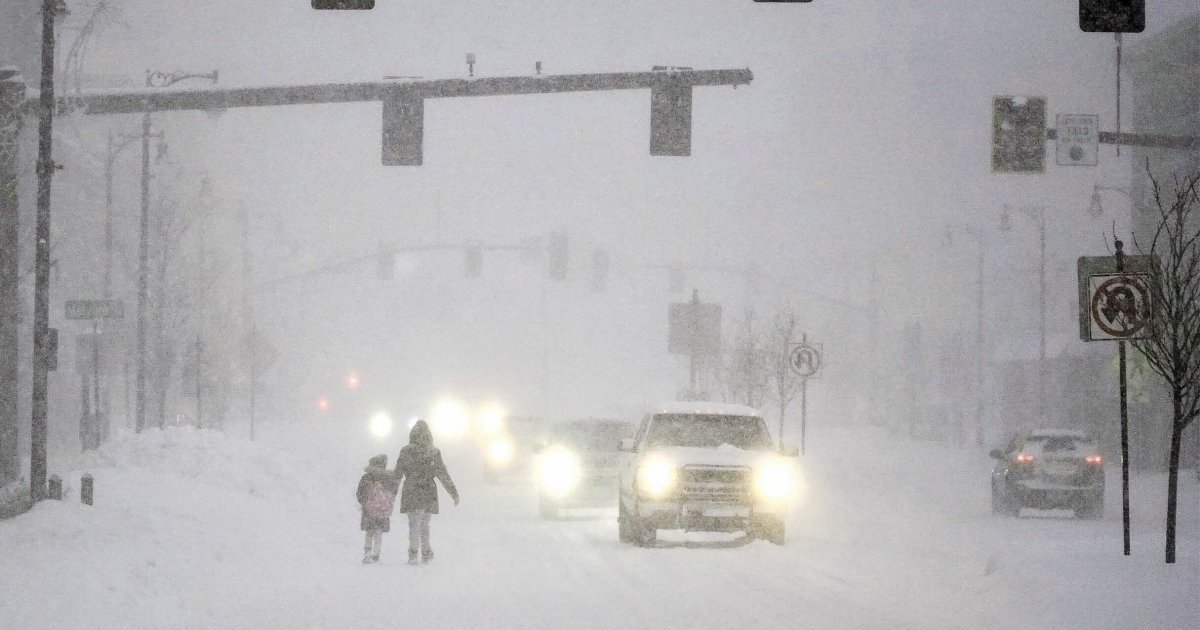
left=29, top=0, right=65, bottom=502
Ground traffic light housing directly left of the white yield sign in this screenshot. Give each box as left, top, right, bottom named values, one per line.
left=991, top=96, right=1046, bottom=173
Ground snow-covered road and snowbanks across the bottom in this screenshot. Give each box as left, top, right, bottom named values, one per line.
left=0, top=420, right=1200, bottom=629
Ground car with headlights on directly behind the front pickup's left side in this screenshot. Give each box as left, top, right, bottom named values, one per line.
left=536, top=418, right=636, bottom=518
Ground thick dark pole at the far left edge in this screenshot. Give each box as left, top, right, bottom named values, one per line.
left=0, top=66, right=25, bottom=487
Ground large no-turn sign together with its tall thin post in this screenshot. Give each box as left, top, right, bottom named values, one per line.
left=1078, top=239, right=1153, bottom=556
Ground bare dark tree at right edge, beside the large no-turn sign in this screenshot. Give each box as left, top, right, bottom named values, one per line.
left=1133, top=162, right=1200, bottom=563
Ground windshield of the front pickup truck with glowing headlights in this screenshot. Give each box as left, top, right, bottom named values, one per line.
left=646, top=414, right=770, bottom=450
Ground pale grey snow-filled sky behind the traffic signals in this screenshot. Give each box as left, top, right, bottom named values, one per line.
left=37, top=0, right=1189, bottom=422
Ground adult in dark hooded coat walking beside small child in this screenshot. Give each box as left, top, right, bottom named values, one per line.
left=395, top=420, right=458, bottom=564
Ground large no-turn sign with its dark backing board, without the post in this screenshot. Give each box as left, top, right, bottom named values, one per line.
left=1078, top=256, right=1153, bottom=341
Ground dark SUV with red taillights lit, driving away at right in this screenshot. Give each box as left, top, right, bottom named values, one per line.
left=991, top=428, right=1104, bottom=518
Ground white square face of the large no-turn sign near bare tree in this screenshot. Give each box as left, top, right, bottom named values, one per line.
left=1087, top=274, right=1151, bottom=340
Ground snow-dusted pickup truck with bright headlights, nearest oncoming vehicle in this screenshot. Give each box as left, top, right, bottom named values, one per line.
left=617, top=402, right=798, bottom=546
